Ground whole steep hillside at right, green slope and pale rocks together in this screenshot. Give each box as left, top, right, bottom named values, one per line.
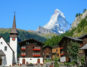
left=71, top=10, right=87, bottom=37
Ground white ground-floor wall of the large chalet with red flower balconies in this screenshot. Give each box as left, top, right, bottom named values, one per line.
left=19, top=57, right=43, bottom=64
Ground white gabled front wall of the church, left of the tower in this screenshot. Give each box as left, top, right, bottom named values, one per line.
left=0, top=37, right=13, bottom=66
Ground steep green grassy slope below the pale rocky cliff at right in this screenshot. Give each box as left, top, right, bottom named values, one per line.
left=73, top=16, right=87, bottom=37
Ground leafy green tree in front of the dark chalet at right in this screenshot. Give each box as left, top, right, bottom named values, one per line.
left=67, top=41, right=79, bottom=64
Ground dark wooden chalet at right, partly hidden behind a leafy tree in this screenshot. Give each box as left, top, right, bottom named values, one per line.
left=59, top=36, right=82, bottom=62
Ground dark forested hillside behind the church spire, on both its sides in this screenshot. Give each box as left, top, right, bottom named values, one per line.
left=0, top=28, right=46, bottom=42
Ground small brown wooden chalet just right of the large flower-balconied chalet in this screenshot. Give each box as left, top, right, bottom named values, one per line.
left=43, top=46, right=52, bottom=60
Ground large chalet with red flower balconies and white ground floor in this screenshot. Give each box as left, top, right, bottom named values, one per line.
left=19, top=39, right=43, bottom=64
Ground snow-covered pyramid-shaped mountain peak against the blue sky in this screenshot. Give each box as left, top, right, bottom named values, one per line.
left=37, top=9, right=70, bottom=34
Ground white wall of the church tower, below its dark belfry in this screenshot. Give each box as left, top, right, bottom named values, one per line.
left=10, top=37, right=17, bottom=63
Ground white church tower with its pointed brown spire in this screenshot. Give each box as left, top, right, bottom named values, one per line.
left=10, top=15, right=18, bottom=63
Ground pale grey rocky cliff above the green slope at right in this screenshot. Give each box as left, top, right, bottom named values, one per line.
left=71, top=10, right=87, bottom=29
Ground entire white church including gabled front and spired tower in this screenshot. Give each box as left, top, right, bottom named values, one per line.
left=0, top=15, right=18, bottom=66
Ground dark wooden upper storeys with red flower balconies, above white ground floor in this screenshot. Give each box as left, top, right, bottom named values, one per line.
left=19, top=39, right=43, bottom=57
